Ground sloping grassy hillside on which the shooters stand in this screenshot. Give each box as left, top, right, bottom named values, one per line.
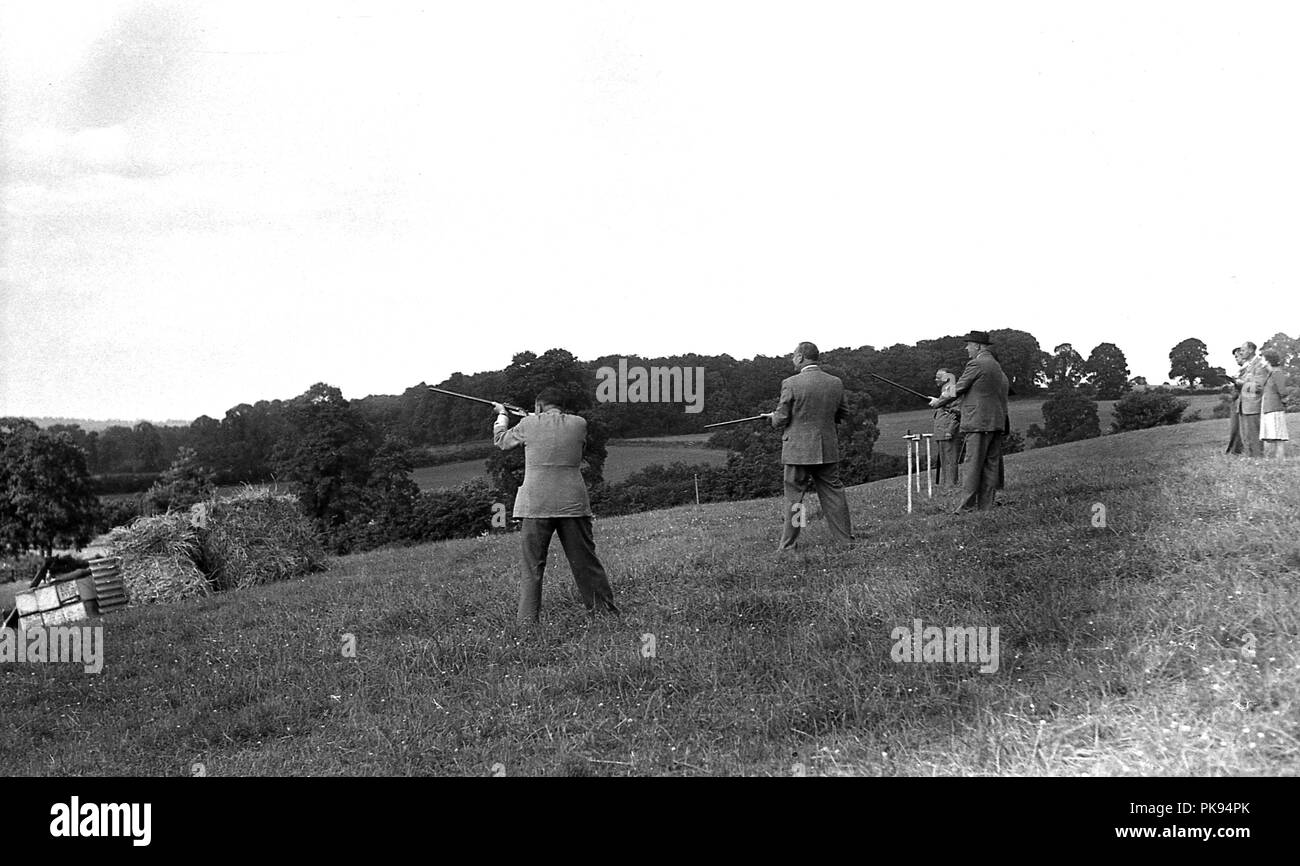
left=0, top=416, right=1300, bottom=775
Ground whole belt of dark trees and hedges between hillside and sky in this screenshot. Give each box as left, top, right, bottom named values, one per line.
left=0, top=332, right=1300, bottom=553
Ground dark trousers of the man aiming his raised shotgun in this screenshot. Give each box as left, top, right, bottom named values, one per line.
left=519, top=518, right=619, bottom=623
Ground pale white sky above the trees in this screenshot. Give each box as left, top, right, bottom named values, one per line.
left=0, top=0, right=1300, bottom=420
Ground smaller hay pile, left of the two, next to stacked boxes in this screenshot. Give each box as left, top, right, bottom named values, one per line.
left=107, top=514, right=212, bottom=605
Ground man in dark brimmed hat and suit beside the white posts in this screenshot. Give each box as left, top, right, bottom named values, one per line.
left=930, top=330, right=1009, bottom=512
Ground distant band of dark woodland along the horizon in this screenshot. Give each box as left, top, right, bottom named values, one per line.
left=40, top=329, right=1180, bottom=481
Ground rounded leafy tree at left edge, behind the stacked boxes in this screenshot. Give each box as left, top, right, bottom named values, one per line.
left=0, top=419, right=99, bottom=557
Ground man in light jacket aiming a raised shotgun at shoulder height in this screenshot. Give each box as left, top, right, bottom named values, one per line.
left=491, top=387, right=619, bottom=625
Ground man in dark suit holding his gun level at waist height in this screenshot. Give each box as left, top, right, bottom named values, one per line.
left=763, top=343, right=853, bottom=550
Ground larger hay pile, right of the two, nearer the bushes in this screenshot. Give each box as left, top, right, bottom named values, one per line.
left=201, top=488, right=325, bottom=589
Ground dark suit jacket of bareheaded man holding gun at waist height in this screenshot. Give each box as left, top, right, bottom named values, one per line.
left=772, top=364, right=849, bottom=466
